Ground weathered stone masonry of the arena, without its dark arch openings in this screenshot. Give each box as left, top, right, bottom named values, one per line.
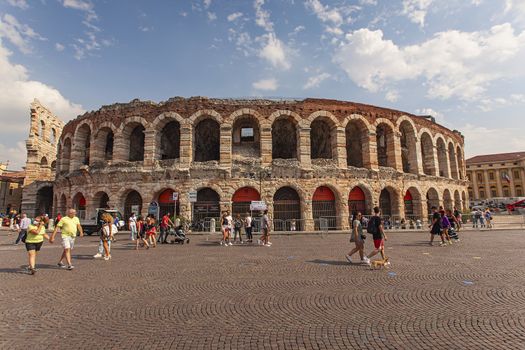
left=54, top=98, right=468, bottom=228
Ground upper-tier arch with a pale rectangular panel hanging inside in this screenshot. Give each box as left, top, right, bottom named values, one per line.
left=229, top=113, right=261, bottom=158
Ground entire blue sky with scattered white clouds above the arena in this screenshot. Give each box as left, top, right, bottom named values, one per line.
left=0, top=0, right=525, bottom=168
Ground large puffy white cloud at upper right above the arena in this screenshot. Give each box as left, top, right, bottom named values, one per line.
left=333, top=23, right=525, bottom=101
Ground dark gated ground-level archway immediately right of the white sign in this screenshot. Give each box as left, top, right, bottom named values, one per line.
left=273, top=187, right=304, bottom=231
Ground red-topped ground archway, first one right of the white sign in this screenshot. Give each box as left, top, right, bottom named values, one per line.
left=312, top=186, right=337, bottom=231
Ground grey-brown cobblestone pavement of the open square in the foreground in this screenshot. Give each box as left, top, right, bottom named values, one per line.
left=0, top=231, right=525, bottom=349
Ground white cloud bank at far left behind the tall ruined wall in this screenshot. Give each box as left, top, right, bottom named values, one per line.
left=0, top=39, right=84, bottom=168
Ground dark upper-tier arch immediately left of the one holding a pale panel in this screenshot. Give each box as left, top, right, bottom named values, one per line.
left=193, top=115, right=221, bottom=162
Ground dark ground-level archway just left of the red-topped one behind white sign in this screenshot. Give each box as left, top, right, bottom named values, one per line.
left=193, top=187, right=221, bottom=231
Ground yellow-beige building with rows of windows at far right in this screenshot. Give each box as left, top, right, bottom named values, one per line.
left=467, top=152, right=525, bottom=201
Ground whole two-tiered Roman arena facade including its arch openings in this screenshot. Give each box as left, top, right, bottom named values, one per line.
left=53, top=97, right=468, bottom=231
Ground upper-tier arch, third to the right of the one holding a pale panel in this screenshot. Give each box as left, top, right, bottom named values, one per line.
left=345, top=118, right=370, bottom=168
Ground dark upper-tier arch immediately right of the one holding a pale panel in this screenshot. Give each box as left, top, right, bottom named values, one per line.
left=272, top=114, right=299, bottom=159
